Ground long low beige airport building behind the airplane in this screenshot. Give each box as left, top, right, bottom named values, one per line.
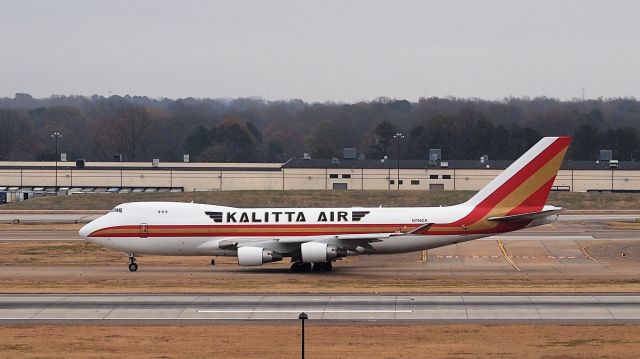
left=0, top=158, right=640, bottom=202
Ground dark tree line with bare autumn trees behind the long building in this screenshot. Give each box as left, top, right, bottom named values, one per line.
left=0, top=94, right=640, bottom=162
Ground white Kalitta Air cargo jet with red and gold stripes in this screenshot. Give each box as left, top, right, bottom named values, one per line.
left=79, top=137, right=571, bottom=272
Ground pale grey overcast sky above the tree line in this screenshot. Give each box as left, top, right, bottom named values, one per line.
left=0, top=0, right=640, bottom=102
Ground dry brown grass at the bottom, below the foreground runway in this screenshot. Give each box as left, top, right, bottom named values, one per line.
left=0, top=321, right=640, bottom=359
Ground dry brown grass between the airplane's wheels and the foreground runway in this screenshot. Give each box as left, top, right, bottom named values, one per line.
left=0, top=241, right=640, bottom=293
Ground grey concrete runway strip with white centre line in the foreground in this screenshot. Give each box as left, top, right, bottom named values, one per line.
left=0, top=295, right=640, bottom=324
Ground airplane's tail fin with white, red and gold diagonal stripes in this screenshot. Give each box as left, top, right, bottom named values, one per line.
left=464, top=137, right=571, bottom=218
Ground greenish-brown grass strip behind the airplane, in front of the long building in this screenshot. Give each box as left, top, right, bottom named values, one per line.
left=0, top=191, right=640, bottom=210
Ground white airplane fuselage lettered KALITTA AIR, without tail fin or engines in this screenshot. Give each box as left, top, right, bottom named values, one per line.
left=80, top=202, right=548, bottom=256
